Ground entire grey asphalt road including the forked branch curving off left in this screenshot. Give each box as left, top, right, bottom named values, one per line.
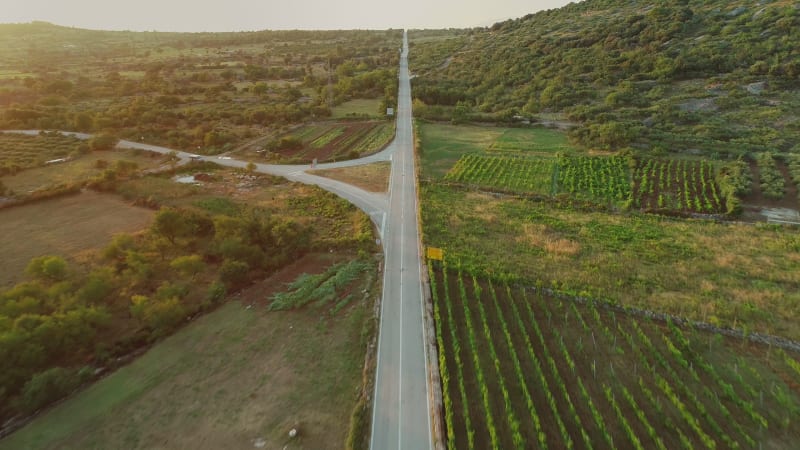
left=4, top=29, right=433, bottom=450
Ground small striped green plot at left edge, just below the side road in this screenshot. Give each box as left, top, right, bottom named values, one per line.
left=0, top=133, right=88, bottom=175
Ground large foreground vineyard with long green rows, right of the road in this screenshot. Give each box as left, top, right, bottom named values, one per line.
left=430, top=269, right=800, bottom=449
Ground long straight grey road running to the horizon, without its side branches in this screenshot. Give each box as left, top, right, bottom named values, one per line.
left=370, top=30, right=432, bottom=450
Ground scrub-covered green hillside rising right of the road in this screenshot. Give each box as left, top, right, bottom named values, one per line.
left=411, top=0, right=800, bottom=158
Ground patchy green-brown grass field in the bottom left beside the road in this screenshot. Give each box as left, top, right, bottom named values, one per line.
left=0, top=254, right=377, bottom=449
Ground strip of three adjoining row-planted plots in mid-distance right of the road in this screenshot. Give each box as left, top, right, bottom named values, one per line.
left=445, top=153, right=736, bottom=214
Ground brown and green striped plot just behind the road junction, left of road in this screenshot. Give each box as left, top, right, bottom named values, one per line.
left=277, top=121, right=394, bottom=163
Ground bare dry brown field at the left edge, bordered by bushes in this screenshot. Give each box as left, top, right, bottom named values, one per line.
left=0, top=191, right=153, bottom=286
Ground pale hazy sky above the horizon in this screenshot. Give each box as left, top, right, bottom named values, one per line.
left=0, top=0, right=569, bottom=31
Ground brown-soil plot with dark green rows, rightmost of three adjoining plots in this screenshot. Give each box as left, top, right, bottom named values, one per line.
left=633, top=159, right=725, bottom=214
